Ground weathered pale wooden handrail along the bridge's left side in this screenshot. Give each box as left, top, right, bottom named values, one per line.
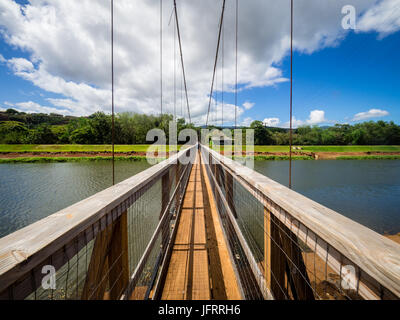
left=0, top=145, right=197, bottom=293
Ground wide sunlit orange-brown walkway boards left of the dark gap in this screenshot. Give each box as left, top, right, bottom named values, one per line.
left=161, top=156, right=217, bottom=300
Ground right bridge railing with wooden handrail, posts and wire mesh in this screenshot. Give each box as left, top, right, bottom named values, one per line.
left=201, top=145, right=400, bottom=300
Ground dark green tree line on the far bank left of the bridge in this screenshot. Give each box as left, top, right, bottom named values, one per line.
left=0, top=109, right=198, bottom=144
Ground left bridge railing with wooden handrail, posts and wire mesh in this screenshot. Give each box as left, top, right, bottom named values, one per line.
left=0, top=146, right=197, bottom=300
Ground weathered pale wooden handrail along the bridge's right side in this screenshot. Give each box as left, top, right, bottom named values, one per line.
left=201, top=145, right=400, bottom=299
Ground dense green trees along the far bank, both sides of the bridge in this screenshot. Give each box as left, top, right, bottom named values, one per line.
left=0, top=109, right=400, bottom=146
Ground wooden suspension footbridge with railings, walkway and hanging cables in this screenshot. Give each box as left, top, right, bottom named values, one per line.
left=0, top=0, right=400, bottom=300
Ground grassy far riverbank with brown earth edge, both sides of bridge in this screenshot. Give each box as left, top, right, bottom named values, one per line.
left=0, top=145, right=400, bottom=163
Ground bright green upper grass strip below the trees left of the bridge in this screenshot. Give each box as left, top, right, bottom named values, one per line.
left=0, top=144, right=181, bottom=152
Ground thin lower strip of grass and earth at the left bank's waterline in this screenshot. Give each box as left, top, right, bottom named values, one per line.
left=0, top=156, right=153, bottom=164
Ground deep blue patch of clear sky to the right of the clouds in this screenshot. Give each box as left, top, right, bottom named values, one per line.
left=225, top=32, right=400, bottom=125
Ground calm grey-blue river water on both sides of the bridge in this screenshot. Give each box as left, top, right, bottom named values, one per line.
left=0, top=160, right=400, bottom=237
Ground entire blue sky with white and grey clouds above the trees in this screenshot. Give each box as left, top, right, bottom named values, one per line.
left=0, top=0, right=400, bottom=127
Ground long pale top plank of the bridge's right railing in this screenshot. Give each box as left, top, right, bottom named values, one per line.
left=202, top=146, right=400, bottom=297
